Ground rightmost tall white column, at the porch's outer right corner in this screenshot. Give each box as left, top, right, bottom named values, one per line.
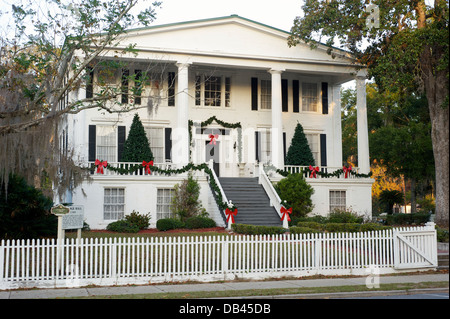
left=356, top=71, right=370, bottom=174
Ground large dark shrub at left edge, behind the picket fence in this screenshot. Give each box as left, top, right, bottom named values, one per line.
left=0, top=175, right=58, bottom=239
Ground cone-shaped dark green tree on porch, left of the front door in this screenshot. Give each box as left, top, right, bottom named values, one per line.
left=122, top=114, right=153, bottom=162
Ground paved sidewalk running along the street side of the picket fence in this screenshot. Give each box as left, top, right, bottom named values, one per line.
left=0, top=273, right=449, bottom=299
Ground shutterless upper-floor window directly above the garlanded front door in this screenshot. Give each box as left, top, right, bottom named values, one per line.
left=195, top=75, right=231, bottom=107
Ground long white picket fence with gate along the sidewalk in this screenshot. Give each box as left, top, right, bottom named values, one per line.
left=0, top=226, right=437, bottom=290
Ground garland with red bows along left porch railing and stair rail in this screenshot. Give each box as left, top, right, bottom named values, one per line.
left=90, top=160, right=236, bottom=211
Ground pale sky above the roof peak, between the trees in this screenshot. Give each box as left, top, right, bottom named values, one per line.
left=142, top=0, right=303, bottom=31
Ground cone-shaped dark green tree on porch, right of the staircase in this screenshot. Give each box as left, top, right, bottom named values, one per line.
left=285, top=123, right=315, bottom=166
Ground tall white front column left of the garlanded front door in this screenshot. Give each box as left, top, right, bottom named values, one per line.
left=172, top=63, right=190, bottom=167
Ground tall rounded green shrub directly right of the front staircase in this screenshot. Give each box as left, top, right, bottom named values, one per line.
left=275, top=174, right=314, bottom=218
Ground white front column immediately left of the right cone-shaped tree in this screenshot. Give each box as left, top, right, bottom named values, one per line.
left=269, top=69, right=284, bottom=169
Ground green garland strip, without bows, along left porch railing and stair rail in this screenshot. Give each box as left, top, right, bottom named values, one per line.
left=91, top=163, right=232, bottom=211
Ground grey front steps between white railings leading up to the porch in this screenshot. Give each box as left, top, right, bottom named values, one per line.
left=219, top=177, right=283, bottom=226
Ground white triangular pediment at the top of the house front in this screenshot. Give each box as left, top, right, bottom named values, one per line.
left=121, top=15, right=352, bottom=63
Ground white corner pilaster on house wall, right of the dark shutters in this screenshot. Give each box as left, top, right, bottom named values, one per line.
left=329, top=85, right=342, bottom=167
